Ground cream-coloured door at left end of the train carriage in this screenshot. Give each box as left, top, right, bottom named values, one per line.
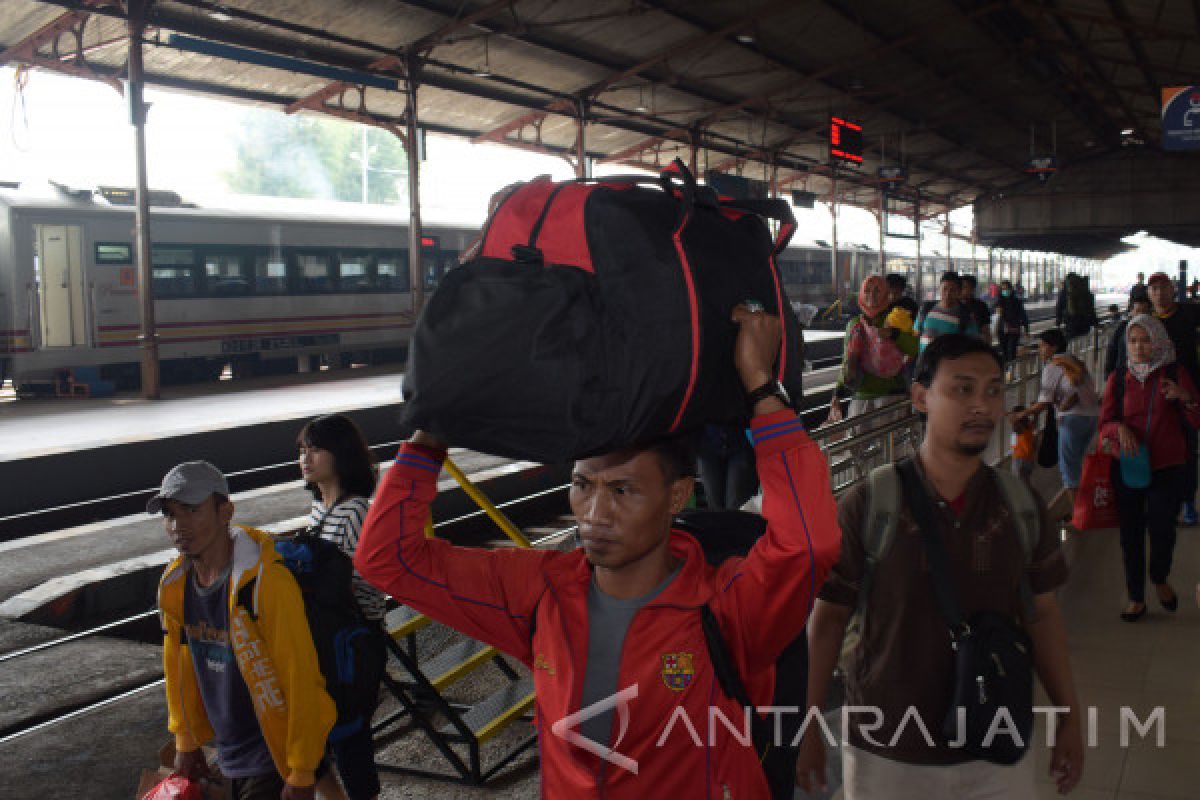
left=34, top=225, right=88, bottom=348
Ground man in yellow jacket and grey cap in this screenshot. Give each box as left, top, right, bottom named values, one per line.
left=153, top=462, right=337, bottom=800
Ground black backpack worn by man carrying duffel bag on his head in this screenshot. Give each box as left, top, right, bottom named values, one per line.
left=674, top=511, right=809, bottom=800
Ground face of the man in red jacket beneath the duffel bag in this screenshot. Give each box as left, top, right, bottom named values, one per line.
left=570, top=451, right=692, bottom=570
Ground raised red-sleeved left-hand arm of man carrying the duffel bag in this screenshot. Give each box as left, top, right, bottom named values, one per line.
left=354, top=432, right=554, bottom=663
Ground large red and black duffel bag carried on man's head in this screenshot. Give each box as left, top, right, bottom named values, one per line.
left=403, top=161, right=804, bottom=463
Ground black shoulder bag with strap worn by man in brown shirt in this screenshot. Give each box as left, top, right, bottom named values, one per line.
left=896, top=459, right=1033, bottom=764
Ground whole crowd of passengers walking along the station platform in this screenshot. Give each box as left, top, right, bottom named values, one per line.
left=148, top=272, right=1200, bottom=800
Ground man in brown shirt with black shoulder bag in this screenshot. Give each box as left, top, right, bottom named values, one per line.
left=797, top=335, right=1084, bottom=800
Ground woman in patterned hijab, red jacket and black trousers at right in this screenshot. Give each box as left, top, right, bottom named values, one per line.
left=1100, top=314, right=1200, bottom=622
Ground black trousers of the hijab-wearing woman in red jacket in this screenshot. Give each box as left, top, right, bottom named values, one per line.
left=1112, top=459, right=1184, bottom=603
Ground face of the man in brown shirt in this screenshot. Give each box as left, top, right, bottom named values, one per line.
left=912, top=353, right=1004, bottom=456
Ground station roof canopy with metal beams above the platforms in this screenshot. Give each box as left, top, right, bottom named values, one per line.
left=0, top=0, right=1200, bottom=256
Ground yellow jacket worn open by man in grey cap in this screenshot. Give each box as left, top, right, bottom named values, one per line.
left=158, top=527, right=337, bottom=787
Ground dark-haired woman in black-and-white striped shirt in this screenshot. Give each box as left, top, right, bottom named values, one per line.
left=296, top=414, right=388, bottom=800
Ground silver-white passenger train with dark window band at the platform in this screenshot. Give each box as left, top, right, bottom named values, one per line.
left=0, top=188, right=984, bottom=389
